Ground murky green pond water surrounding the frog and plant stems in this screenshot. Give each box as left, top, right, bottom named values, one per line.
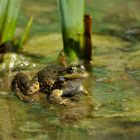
left=0, top=0, right=140, bottom=140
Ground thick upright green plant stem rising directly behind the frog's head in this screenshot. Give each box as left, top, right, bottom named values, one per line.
left=58, top=0, right=91, bottom=64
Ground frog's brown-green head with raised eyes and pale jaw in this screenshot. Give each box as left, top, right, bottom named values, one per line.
left=59, top=65, right=89, bottom=81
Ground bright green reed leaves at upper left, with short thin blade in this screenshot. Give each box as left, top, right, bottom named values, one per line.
left=0, top=0, right=32, bottom=48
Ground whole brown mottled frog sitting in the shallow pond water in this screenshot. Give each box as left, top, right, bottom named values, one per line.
left=11, top=64, right=89, bottom=104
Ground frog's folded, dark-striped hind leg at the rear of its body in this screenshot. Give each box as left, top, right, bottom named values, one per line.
left=11, top=73, right=39, bottom=102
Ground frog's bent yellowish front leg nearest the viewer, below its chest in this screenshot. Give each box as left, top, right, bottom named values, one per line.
left=49, top=89, right=68, bottom=105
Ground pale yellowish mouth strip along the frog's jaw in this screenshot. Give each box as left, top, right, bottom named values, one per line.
left=61, top=72, right=89, bottom=80
